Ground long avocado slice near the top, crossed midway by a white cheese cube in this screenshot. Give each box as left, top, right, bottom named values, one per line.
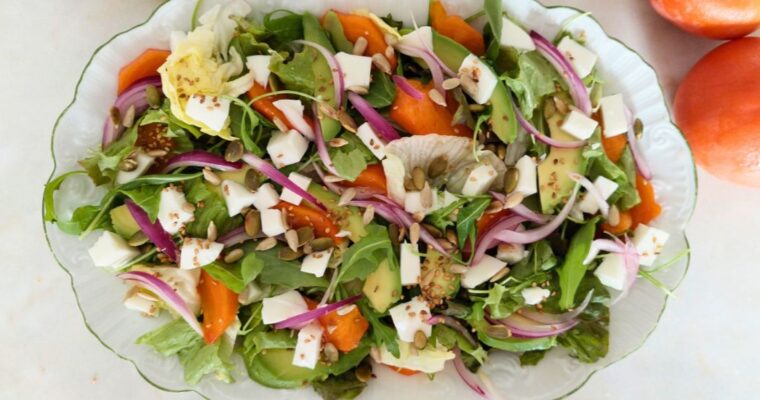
left=433, top=31, right=517, bottom=143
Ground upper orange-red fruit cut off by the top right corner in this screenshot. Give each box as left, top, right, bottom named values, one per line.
left=650, top=0, right=760, bottom=39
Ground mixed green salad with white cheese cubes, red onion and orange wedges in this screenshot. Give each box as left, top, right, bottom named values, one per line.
left=45, top=0, right=668, bottom=399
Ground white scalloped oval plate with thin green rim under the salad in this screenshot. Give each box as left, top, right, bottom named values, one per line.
left=45, top=0, right=697, bottom=400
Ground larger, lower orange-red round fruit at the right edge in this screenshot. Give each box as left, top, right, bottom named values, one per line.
left=673, top=37, right=760, bottom=187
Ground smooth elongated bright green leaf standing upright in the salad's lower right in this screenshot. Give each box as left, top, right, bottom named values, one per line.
left=558, top=218, right=598, bottom=310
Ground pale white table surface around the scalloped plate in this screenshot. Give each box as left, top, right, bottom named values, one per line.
left=0, top=0, right=760, bottom=400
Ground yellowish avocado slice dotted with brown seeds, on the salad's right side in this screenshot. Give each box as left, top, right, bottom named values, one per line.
left=538, top=114, right=586, bottom=214
